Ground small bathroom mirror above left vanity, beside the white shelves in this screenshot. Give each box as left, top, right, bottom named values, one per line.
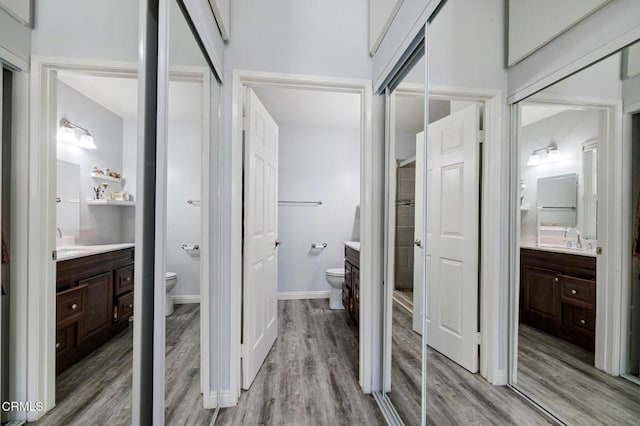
left=56, top=160, right=80, bottom=245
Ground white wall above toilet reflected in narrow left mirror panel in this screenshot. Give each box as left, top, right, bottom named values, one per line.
left=167, top=120, right=202, bottom=296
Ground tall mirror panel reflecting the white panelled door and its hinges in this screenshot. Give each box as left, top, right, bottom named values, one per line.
left=425, top=0, right=548, bottom=424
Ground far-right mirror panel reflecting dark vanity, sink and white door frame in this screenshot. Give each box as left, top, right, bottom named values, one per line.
left=510, top=41, right=640, bottom=424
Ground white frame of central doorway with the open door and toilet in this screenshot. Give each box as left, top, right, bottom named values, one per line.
left=230, top=69, right=384, bottom=405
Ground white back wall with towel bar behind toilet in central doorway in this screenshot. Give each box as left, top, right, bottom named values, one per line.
left=278, top=127, right=360, bottom=292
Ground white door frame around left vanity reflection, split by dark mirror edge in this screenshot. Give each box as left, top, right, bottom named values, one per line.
left=27, top=56, right=218, bottom=421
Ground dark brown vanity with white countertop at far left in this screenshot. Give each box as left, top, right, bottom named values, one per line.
left=56, top=244, right=134, bottom=375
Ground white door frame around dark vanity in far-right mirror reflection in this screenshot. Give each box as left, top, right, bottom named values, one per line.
left=508, top=94, right=631, bottom=386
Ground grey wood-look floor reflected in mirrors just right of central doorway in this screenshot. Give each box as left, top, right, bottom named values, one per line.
left=389, top=303, right=552, bottom=425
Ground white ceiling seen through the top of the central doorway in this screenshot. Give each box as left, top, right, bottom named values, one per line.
left=253, top=87, right=360, bottom=129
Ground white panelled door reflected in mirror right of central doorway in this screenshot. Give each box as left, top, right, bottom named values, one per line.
left=414, top=105, right=480, bottom=373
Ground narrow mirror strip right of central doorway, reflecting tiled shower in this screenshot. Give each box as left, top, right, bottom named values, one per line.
left=387, top=58, right=425, bottom=424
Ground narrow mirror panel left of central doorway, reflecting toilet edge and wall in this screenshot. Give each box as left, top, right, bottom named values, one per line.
left=165, top=0, right=218, bottom=424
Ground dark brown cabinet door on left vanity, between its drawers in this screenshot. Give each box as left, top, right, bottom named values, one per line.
left=78, top=272, right=113, bottom=342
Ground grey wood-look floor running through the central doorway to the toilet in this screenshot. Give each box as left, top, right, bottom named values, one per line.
left=216, top=299, right=385, bottom=425
